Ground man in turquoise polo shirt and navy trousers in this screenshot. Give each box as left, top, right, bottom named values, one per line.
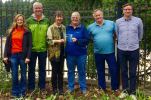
left=88, top=9, right=118, bottom=95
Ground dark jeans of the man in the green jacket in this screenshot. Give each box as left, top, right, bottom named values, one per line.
left=28, top=52, right=47, bottom=90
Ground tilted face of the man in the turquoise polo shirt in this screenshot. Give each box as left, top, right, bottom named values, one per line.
left=93, top=10, right=103, bottom=24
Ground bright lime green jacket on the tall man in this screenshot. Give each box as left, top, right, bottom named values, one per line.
left=27, top=15, right=50, bottom=52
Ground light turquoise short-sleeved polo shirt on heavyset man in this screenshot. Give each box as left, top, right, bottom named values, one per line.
left=88, top=20, right=115, bottom=54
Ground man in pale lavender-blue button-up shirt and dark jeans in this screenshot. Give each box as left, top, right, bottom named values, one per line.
left=116, top=4, right=143, bottom=100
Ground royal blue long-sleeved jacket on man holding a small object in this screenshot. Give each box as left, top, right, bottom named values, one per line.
left=65, top=24, right=89, bottom=56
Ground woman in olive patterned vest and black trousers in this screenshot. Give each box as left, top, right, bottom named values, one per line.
left=47, top=11, right=66, bottom=95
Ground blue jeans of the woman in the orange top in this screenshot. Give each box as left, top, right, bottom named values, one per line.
left=10, top=53, right=27, bottom=96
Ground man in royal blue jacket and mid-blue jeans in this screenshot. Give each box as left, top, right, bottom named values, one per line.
left=65, top=12, right=89, bottom=94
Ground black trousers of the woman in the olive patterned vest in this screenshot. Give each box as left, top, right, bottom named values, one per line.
left=51, top=56, right=64, bottom=92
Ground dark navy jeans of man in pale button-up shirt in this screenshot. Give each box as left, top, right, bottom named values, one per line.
left=118, top=49, right=139, bottom=94
